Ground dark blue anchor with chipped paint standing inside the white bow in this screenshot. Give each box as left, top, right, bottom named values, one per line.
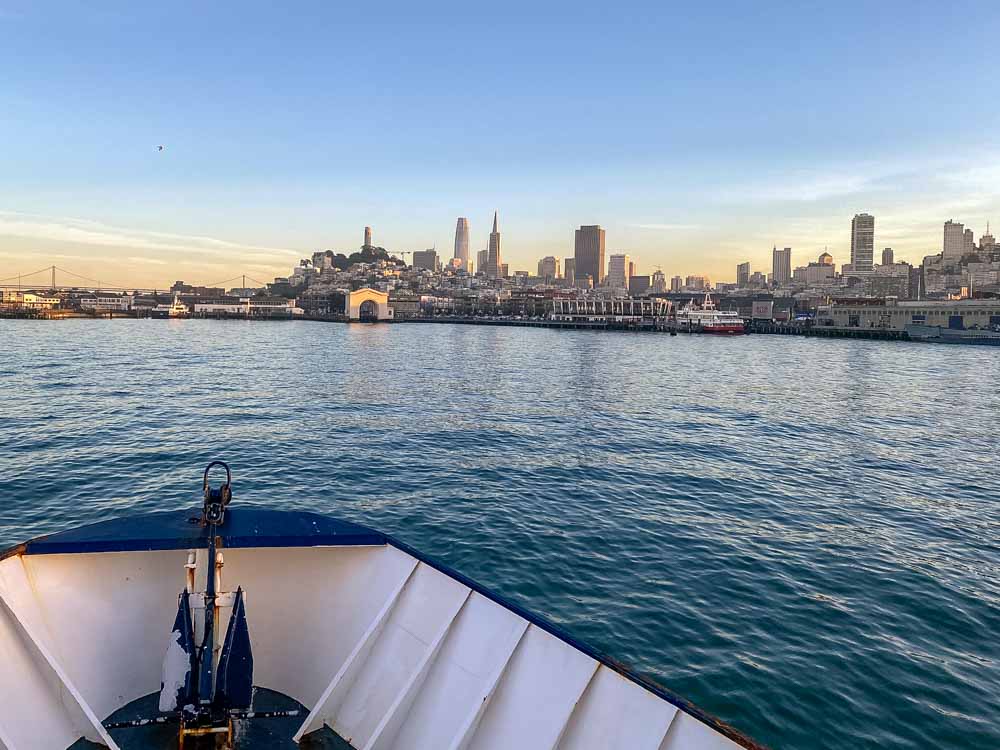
left=104, top=461, right=298, bottom=750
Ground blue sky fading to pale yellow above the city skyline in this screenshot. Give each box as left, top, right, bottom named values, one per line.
left=0, top=0, right=1000, bottom=287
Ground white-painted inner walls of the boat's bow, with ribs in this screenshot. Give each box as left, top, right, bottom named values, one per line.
left=0, top=546, right=752, bottom=750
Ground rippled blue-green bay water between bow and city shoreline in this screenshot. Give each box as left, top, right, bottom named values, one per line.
left=0, top=320, right=1000, bottom=749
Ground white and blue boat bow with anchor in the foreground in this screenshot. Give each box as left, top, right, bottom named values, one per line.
left=0, top=462, right=758, bottom=750
